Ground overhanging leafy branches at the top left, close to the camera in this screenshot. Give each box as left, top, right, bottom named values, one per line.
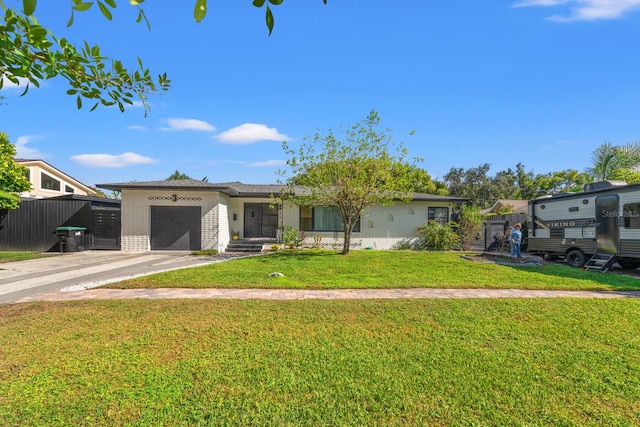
left=0, top=0, right=327, bottom=115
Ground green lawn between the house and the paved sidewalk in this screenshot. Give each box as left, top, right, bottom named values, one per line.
left=105, top=250, right=640, bottom=290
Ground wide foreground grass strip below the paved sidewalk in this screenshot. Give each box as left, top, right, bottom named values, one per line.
left=0, top=299, right=640, bottom=426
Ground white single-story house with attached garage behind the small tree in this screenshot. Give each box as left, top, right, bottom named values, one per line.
left=98, top=180, right=465, bottom=252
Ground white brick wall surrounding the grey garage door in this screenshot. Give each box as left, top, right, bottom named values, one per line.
left=121, top=189, right=225, bottom=251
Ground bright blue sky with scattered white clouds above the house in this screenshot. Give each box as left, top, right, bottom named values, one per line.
left=0, top=0, right=640, bottom=185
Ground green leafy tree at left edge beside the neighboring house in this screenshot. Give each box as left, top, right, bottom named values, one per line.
left=0, top=132, right=31, bottom=210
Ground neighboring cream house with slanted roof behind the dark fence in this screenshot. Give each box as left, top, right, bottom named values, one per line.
left=15, top=159, right=96, bottom=199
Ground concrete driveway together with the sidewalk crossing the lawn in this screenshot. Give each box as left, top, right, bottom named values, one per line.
left=0, top=251, right=640, bottom=304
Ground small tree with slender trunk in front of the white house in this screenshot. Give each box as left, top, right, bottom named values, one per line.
left=279, top=111, right=418, bottom=255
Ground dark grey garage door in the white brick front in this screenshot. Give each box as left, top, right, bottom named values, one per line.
left=151, top=206, right=201, bottom=251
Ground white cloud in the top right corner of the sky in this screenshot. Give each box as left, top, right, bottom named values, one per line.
left=513, top=0, right=640, bottom=22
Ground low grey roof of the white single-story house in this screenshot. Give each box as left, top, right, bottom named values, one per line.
left=97, top=179, right=467, bottom=202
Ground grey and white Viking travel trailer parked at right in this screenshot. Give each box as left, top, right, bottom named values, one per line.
left=527, top=181, right=640, bottom=268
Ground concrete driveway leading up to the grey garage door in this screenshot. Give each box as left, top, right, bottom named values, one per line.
left=0, top=251, right=247, bottom=304
